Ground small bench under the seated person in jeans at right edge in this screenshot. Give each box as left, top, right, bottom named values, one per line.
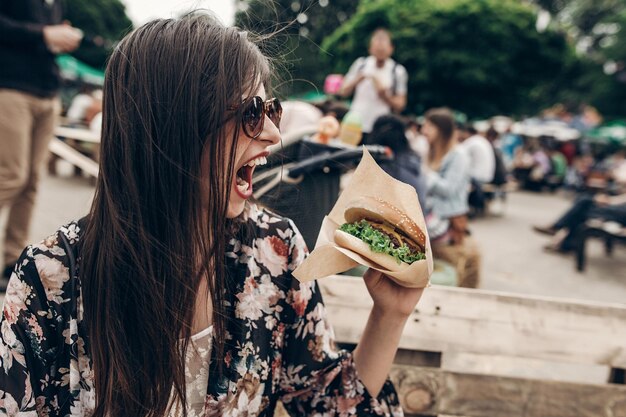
left=576, top=219, right=626, bottom=272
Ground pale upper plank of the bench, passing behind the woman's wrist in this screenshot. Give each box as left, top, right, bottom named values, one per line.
left=319, top=277, right=626, bottom=368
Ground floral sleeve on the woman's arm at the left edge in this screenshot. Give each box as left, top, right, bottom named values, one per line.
left=0, top=246, right=59, bottom=417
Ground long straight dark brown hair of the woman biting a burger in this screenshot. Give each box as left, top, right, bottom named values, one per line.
left=80, top=14, right=270, bottom=417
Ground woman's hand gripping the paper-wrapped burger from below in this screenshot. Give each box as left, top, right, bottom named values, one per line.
left=363, top=268, right=424, bottom=318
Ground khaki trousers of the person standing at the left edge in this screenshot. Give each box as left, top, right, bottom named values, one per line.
left=0, top=89, right=60, bottom=264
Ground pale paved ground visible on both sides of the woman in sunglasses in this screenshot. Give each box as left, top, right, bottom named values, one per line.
left=1, top=167, right=626, bottom=303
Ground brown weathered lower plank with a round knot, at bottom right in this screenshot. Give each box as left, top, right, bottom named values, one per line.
left=391, top=365, right=626, bottom=417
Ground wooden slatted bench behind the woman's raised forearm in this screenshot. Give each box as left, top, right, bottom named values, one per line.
left=320, top=276, right=626, bottom=417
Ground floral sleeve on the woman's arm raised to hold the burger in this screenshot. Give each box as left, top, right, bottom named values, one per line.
left=280, top=219, right=403, bottom=417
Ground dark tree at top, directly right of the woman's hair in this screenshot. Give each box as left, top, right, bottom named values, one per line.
left=235, top=0, right=359, bottom=94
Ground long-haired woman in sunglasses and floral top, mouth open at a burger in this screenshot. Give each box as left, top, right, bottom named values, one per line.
left=0, top=15, right=421, bottom=417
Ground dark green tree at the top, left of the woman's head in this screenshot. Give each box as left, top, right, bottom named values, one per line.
left=64, top=0, right=132, bottom=68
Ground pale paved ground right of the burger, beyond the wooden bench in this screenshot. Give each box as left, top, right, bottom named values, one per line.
left=471, top=192, right=626, bottom=303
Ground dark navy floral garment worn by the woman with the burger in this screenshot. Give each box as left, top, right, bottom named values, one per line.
left=0, top=205, right=403, bottom=417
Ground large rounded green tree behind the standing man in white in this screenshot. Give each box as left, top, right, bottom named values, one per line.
left=323, top=0, right=575, bottom=117
